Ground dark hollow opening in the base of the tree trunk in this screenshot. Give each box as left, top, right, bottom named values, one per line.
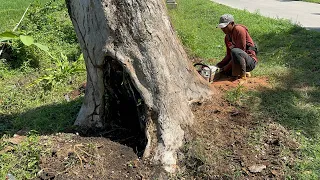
left=102, top=57, right=147, bottom=157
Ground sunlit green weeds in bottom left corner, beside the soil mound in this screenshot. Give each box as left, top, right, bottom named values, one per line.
left=0, top=134, right=42, bottom=179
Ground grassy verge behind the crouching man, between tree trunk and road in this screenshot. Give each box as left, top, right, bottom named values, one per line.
left=170, top=0, right=320, bottom=179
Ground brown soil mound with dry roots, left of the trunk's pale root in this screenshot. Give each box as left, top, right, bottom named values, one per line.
left=37, top=133, right=156, bottom=180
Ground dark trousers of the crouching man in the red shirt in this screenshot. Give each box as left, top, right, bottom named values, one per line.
left=231, top=48, right=256, bottom=76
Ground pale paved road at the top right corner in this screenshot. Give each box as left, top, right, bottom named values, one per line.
left=212, top=0, right=320, bottom=31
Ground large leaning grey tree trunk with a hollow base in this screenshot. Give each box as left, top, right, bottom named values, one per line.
left=66, top=0, right=213, bottom=172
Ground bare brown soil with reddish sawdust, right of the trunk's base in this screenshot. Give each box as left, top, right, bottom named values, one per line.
left=180, top=78, right=299, bottom=179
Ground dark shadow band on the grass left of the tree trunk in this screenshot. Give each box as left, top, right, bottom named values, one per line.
left=0, top=98, right=83, bottom=135
